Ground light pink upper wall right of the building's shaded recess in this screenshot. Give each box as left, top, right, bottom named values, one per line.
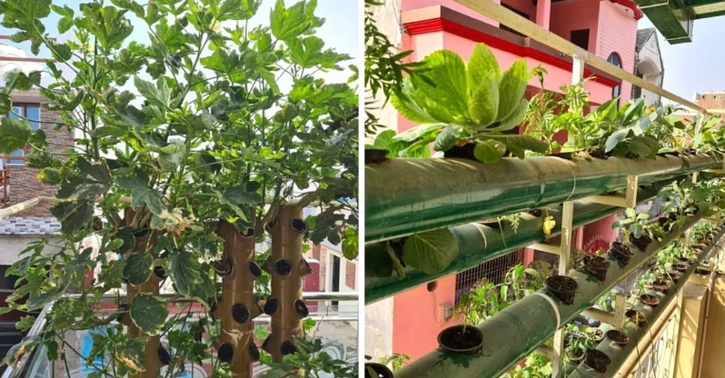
left=596, top=1, right=637, bottom=104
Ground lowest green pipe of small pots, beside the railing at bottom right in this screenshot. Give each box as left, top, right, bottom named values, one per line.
left=569, top=227, right=724, bottom=378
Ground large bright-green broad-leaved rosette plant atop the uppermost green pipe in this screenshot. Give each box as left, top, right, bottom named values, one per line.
left=392, top=44, right=547, bottom=163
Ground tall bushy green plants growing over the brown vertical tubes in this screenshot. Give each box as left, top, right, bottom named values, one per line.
left=0, top=0, right=358, bottom=377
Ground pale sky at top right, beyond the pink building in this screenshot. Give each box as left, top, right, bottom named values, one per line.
left=638, top=16, right=725, bottom=100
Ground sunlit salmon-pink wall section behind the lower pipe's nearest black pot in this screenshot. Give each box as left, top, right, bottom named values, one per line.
left=393, top=274, right=461, bottom=359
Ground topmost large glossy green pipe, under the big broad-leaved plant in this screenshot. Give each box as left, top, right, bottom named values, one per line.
left=365, top=154, right=722, bottom=243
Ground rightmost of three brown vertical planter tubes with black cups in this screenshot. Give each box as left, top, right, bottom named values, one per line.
left=263, top=203, right=311, bottom=363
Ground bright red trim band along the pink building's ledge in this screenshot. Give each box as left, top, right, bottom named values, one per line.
left=405, top=18, right=627, bottom=88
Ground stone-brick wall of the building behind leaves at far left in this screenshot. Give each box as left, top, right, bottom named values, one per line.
left=3, top=92, right=74, bottom=218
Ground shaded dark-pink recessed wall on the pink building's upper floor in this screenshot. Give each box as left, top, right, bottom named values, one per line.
left=549, top=0, right=596, bottom=52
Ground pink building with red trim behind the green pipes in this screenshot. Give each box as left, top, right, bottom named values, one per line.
left=366, top=0, right=642, bottom=359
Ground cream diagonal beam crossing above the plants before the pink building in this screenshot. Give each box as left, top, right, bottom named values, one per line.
left=455, top=0, right=705, bottom=112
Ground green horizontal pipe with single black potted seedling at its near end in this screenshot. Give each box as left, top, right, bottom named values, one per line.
left=395, top=212, right=702, bottom=378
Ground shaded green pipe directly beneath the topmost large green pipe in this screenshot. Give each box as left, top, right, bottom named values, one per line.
left=365, top=180, right=672, bottom=304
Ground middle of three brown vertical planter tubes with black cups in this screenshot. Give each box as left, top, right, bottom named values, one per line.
left=217, top=218, right=262, bottom=378
